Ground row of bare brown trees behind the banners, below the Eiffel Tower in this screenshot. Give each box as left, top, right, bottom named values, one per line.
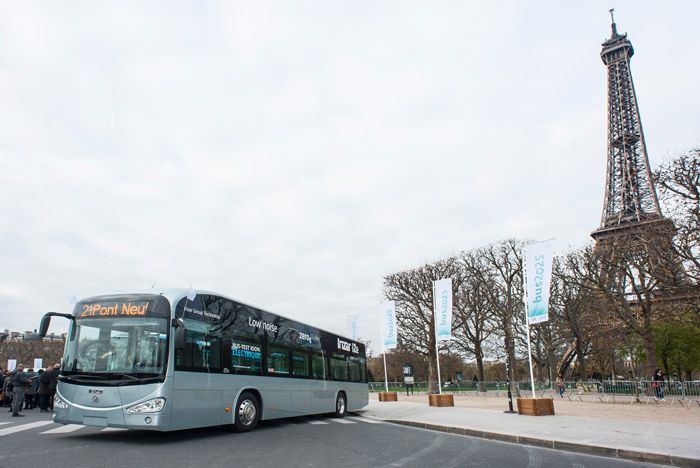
left=383, top=150, right=700, bottom=390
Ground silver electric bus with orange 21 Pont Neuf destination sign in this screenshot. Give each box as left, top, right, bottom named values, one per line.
left=39, top=289, right=368, bottom=432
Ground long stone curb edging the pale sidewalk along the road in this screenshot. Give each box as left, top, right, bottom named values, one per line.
left=383, top=419, right=700, bottom=467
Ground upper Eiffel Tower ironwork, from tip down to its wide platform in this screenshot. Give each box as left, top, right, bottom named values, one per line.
left=592, top=10, right=673, bottom=241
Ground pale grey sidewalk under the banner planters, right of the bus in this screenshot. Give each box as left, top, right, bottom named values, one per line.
left=360, top=395, right=700, bottom=467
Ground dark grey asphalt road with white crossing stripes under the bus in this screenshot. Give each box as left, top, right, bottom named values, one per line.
left=0, top=408, right=655, bottom=468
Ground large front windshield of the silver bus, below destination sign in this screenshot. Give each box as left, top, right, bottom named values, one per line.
left=63, top=317, right=168, bottom=380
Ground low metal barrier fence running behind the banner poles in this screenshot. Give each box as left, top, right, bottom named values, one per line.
left=369, top=380, right=700, bottom=407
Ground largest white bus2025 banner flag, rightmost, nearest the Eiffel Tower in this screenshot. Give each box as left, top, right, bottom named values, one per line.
left=524, top=240, right=554, bottom=325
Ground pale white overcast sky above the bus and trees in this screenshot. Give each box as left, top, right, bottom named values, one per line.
left=0, top=0, right=700, bottom=352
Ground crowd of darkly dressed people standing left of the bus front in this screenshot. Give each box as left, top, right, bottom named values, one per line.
left=0, top=364, right=61, bottom=417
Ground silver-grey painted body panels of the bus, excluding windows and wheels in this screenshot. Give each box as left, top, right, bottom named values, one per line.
left=47, top=290, right=368, bottom=431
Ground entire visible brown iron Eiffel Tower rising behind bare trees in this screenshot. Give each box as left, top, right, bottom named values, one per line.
left=557, top=10, right=682, bottom=375
